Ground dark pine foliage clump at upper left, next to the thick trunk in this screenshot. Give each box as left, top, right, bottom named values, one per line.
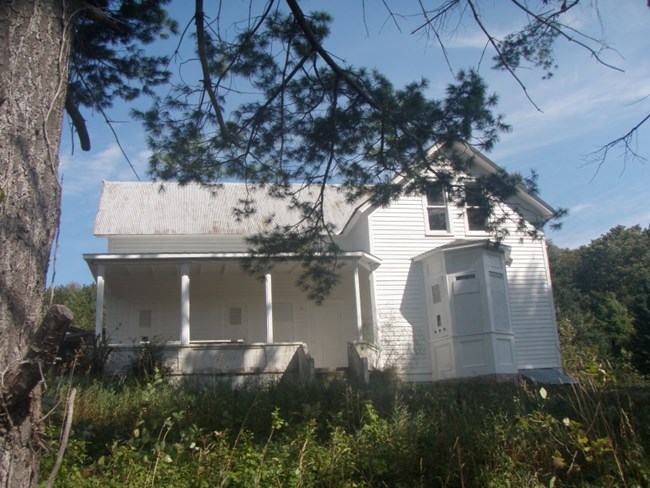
left=65, top=0, right=176, bottom=151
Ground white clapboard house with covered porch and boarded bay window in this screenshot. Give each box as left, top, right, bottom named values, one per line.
left=84, top=143, right=562, bottom=381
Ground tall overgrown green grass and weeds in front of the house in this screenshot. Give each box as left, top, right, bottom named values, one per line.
left=43, top=377, right=650, bottom=487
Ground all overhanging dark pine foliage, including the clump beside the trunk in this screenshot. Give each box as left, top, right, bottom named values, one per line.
left=66, top=0, right=636, bottom=299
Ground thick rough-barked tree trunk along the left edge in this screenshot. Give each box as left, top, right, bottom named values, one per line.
left=0, top=0, right=76, bottom=487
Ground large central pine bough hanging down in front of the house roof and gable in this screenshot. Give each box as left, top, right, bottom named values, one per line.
left=136, top=0, right=588, bottom=300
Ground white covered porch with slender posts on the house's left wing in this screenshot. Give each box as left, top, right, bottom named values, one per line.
left=84, top=252, right=380, bottom=377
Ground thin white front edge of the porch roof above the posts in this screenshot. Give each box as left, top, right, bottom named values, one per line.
left=83, top=251, right=381, bottom=278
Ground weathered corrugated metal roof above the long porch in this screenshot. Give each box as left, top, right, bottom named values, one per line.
left=93, top=181, right=356, bottom=236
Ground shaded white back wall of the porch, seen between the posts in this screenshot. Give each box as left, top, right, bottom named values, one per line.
left=106, top=260, right=356, bottom=368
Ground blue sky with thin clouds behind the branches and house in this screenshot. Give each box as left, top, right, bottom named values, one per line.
left=50, top=0, right=650, bottom=284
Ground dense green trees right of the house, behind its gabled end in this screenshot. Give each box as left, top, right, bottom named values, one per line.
left=549, top=225, right=650, bottom=374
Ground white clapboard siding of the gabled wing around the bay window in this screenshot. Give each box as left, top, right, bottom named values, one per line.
left=369, top=196, right=561, bottom=378
